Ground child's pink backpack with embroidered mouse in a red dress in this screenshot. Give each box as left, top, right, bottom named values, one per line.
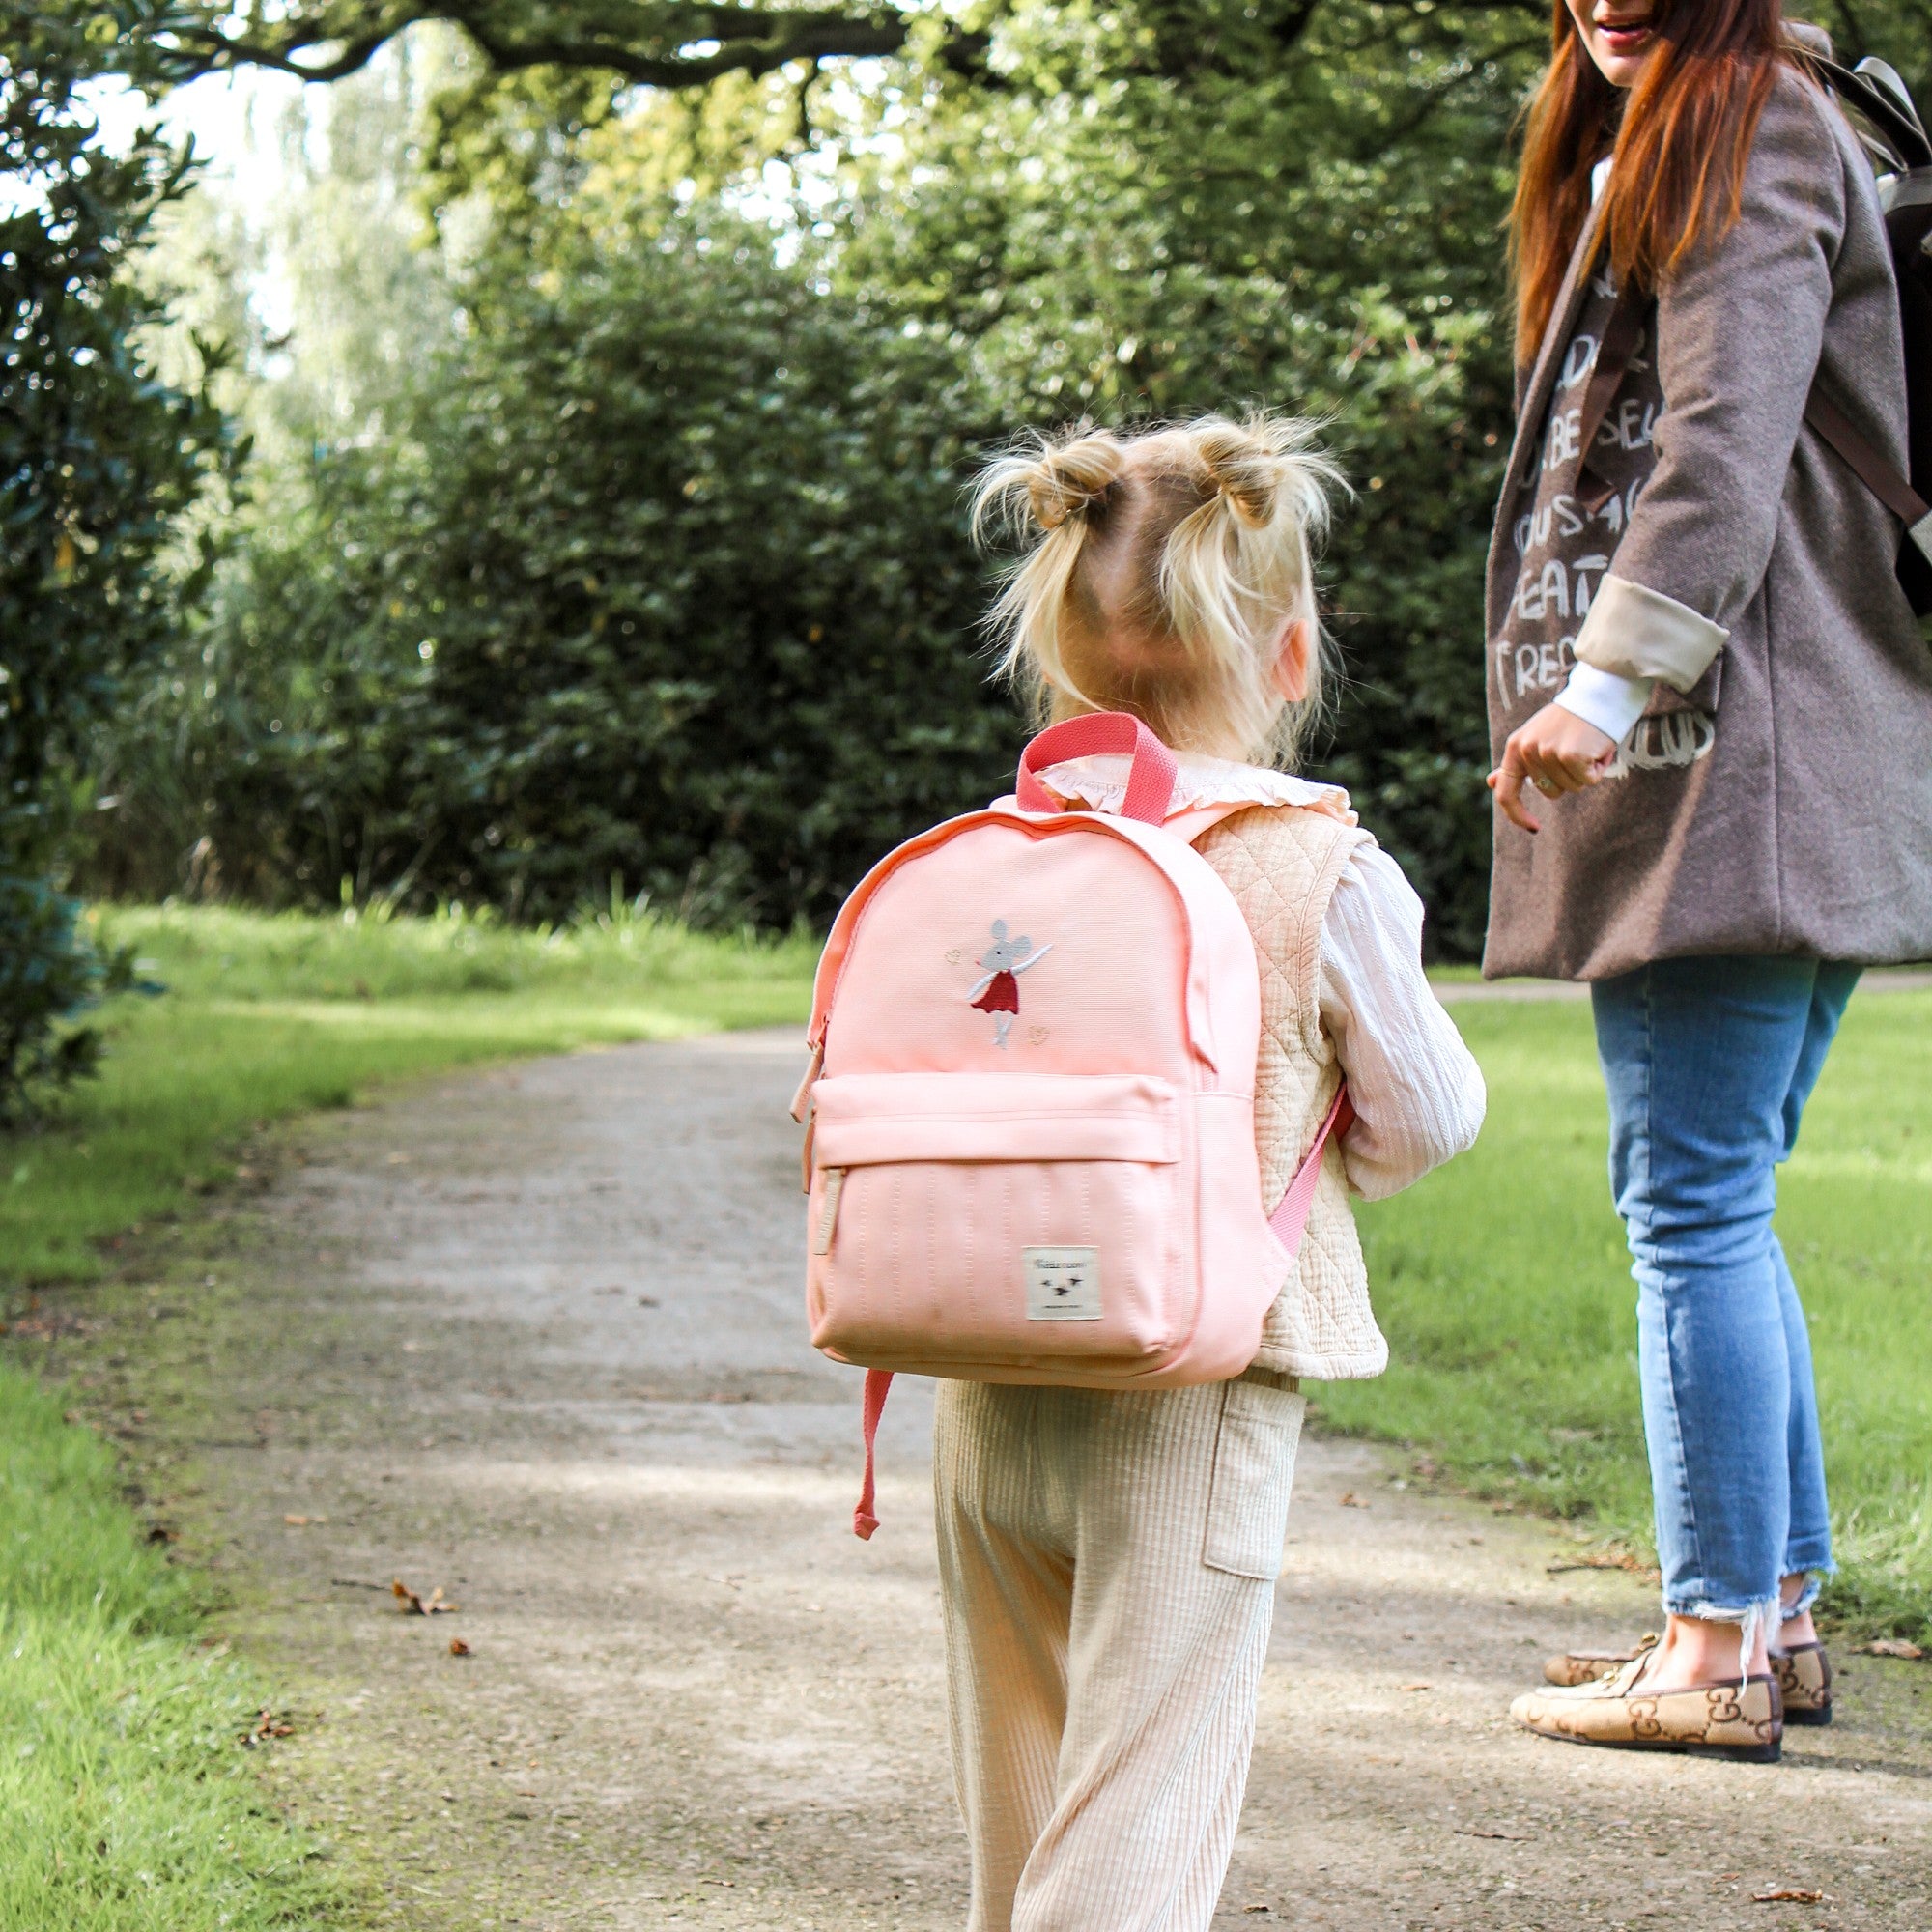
left=792, top=713, right=1352, bottom=1536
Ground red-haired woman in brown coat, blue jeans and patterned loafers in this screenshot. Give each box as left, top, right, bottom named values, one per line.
left=1484, top=0, right=1932, bottom=1758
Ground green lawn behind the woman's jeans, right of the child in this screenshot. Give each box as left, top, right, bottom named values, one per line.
left=1318, top=993, right=1932, bottom=1638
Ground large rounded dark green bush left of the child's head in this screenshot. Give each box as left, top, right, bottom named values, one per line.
left=89, top=211, right=1012, bottom=923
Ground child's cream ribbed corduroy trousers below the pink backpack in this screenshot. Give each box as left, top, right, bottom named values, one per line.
left=933, top=1370, right=1304, bottom=1932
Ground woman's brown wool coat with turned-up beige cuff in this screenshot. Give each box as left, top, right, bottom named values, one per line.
left=1484, top=70, right=1932, bottom=980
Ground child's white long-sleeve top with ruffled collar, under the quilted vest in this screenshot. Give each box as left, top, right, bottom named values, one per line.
left=1041, top=755, right=1488, bottom=1200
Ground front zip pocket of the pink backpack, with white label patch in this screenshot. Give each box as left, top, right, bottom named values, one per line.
left=808, top=1074, right=1194, bottom=1376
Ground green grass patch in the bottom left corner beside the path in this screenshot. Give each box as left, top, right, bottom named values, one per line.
left=0, top=1370, right=354, bottom=1932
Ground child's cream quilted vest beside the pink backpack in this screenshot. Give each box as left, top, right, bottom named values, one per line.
left=1196, top=806, right=1389, bottom=1381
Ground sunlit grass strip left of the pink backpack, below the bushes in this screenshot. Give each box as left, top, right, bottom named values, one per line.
left=0, top=906, right=817, bottom=1289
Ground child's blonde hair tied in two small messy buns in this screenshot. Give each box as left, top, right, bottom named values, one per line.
left=974, top=413, right=1347, bottom=765
